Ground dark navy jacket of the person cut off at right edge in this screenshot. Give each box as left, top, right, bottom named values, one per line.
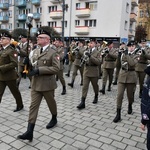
left=141, top=78, right=150, bottom=125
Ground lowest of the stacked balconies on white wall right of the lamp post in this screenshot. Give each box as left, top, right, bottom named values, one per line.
left=75, top=26, right=89, bottom=35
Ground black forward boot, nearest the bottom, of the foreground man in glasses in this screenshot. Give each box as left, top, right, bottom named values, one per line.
left=17, top=123, right=35, bottom=142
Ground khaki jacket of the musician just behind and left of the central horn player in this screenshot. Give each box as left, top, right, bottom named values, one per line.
left=73, top=47, right=86, bottom=66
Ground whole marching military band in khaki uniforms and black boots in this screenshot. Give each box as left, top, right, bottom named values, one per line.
left=0, top=28, right=150, bottom=149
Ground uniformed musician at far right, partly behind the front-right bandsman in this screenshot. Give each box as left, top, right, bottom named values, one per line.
left=135, top=39, right=150, bottom=98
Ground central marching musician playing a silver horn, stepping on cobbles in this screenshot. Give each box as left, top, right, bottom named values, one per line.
left=77, top=39, right=101, bottom=109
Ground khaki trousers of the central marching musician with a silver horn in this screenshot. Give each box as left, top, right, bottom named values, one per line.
left=82, top=76, right=99, bottom=98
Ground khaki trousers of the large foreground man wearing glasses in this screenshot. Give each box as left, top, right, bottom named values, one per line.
left=28, top=90, right=57, bottom=124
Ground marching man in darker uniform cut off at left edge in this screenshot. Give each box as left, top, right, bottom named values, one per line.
left=0, top=30, right=23, bottom=112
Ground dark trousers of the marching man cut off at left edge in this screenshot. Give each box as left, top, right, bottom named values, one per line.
left=0, top=80, right=23, bottom=107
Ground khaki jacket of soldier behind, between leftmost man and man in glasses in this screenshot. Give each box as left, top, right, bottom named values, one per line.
left=18, top=43, right=27, bottom=66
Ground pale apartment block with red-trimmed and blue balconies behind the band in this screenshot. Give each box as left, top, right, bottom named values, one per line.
left=0, top=0, right=138, bottom=42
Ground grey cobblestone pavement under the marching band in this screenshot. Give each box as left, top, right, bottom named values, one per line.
left=0, top=67, right=146, bottom=150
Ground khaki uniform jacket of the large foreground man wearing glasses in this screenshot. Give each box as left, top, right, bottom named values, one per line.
left=31, top=46, right=60, bottom=91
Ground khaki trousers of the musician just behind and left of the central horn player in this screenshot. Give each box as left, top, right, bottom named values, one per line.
left=72, top=65, right=83, bottom=83
